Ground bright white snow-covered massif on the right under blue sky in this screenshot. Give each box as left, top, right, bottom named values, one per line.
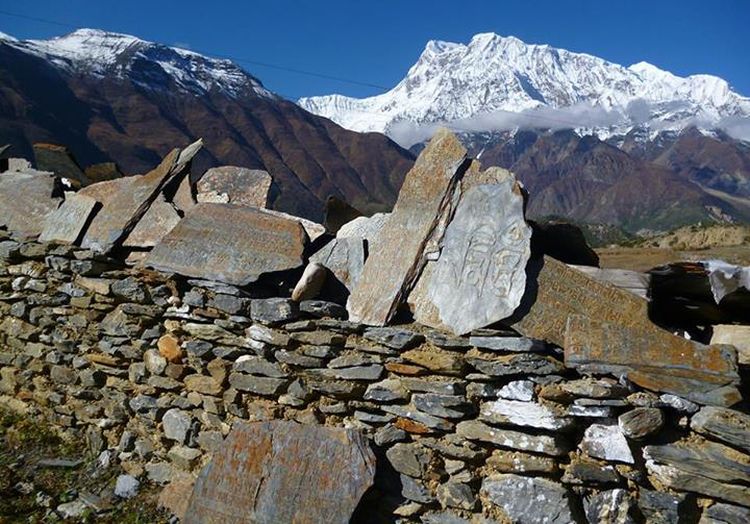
left=299, top=33, right=750, bottom=147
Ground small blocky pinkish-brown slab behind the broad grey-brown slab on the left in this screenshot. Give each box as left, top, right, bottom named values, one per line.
left=196, top=166, right=273, bottom=208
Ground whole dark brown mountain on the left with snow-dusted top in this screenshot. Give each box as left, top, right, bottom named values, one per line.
left=0, top=29, right=413, bottom=219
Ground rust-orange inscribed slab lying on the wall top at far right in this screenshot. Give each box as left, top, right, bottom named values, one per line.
left=564, top=315, right=741, bottom=406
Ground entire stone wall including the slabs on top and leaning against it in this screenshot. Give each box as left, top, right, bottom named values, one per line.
left=0, top=132, right=750, bottom=524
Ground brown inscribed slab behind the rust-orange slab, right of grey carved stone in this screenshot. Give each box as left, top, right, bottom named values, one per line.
left=506, top=257, right=653, bottom=347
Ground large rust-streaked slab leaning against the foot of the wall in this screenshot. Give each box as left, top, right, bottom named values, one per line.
left=184, top=421, right=375, bottom=524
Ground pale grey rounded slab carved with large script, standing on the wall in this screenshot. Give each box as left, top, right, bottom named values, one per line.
left=414, top=168, right=531, bottom=335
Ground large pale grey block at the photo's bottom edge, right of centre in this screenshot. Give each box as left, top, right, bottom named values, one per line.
left=481, top=473, right=576, bottom=524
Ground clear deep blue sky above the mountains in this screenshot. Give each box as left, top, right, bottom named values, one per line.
left=0, top=0, right=750, bottom=98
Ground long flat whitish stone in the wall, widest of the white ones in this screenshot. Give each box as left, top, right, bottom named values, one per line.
left=479, top=399, right=574, bottom=431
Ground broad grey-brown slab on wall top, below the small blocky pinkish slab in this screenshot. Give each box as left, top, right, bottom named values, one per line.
left=144, top=203, right=307, bottom=286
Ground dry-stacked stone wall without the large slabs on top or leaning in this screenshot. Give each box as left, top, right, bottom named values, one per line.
left=0, top=236, right=750, bottom=524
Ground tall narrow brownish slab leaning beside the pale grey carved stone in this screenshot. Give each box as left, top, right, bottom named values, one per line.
left=347, top=129, right=467, bottom=326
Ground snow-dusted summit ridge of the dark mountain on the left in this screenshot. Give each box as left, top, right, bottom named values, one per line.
left=0, top=29, right=275, bottom=97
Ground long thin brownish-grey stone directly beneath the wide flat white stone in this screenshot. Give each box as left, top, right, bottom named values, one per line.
left=456, top=420, right=568, bottom=456
